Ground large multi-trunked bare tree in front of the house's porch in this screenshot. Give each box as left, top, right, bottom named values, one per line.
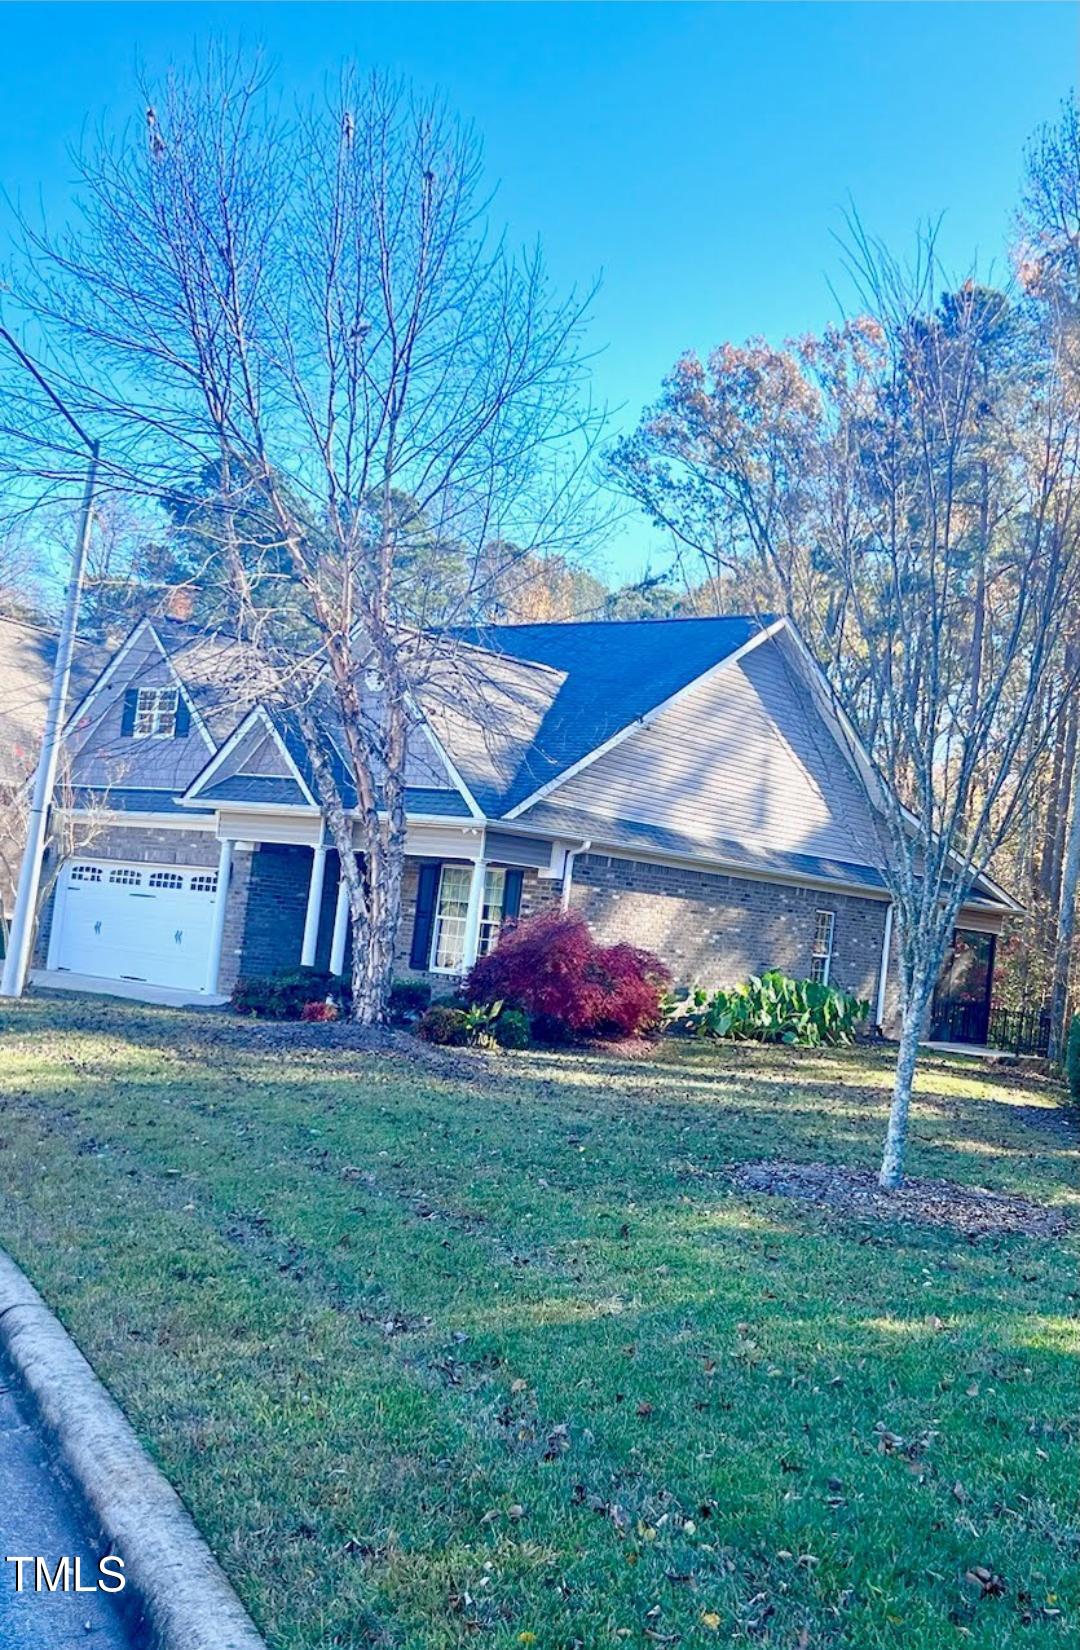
left=7, top=53, right=597, bottom=1021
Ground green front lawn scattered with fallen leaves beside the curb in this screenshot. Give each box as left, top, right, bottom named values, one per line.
left=0, top=1000, right=1080, bottom=1650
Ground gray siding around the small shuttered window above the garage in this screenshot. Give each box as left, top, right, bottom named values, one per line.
left=69, top=632, right=211, bottom=790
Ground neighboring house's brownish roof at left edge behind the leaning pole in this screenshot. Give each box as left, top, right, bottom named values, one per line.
left=0, top=617, right=109, bottom=784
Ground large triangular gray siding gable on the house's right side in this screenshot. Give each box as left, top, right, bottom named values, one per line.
left=550, top=642, right=880, bottom=865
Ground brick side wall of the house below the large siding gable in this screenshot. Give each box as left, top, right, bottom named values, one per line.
left=560, top=853, right=885, bottom=1005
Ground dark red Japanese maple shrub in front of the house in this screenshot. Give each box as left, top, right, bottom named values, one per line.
left=467, top=911, right=671, bottom=1041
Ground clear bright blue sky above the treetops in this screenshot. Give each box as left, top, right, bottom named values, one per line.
left=0, top=0, right=1080, bottom=576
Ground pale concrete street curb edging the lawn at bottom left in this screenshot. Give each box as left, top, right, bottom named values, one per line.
left=0, top=1249, right=267, bottom=1650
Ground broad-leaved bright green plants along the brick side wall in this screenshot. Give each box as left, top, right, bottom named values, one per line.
left=679, top=970, right=871, bottom=1048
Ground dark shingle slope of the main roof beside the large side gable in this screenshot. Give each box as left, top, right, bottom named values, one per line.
left=450, top=615, right=772, bottom=813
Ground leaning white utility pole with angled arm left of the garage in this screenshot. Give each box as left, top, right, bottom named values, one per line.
left=0, top=327, right=97, bottom=997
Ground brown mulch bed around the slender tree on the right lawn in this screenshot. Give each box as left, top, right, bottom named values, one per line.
left=732, top=1163, right=1068, bottom=1238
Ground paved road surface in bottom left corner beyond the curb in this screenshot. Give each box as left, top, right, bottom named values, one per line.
left=0, top=1361, right=139, bottom=1650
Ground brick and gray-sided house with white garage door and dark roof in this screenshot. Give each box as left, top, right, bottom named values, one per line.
left=10, top=617, right=1016, bottom=1040
